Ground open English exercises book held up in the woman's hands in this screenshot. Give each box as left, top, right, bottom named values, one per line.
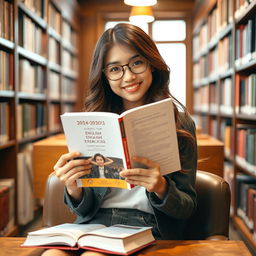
left=61, top=98, right=181, bottom=189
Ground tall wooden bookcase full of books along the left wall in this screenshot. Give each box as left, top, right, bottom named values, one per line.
left=0, top=0, right=79, bottom=236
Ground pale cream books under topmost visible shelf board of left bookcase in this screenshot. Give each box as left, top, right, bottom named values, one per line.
left=19, top=12, right=46, bottom=56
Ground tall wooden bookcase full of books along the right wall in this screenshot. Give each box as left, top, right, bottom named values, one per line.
left=193, top=0, right=256, bottom=251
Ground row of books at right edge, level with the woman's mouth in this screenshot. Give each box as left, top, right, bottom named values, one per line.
left=235, top=73, right=256, bottom=115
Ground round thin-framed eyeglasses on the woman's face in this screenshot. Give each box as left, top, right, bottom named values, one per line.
left=102, top=57, right=148, bottom=81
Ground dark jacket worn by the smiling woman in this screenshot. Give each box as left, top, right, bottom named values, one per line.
left=65, top=115, right=197, bottom=240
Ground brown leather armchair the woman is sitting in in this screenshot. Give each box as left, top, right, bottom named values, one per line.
left=43, top=171, right=230, bottom=240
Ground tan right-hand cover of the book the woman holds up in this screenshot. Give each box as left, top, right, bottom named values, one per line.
left=123, top=99, right=181, bottom=174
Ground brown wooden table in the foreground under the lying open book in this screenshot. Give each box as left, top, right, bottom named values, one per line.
left=0, top=237, right=251, bottom=256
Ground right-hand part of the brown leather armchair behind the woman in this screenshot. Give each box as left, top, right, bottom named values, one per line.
left=184, top=171, right=230, bottom=240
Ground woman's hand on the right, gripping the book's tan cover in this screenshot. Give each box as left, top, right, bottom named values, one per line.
left=120, top=156, right=168, bottom=199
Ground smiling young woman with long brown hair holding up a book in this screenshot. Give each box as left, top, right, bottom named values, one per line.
left=42, top=24, right=197, bottom=255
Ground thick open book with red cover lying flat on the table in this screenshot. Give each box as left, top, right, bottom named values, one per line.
left=21, top=223, right=155, bottom=255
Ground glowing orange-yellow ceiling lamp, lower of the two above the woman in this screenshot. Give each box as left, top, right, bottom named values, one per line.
left=129, top=6, right=155, bottom=23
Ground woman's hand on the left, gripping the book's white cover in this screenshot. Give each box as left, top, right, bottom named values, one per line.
left=53, top=152, right=92, bottom=201
